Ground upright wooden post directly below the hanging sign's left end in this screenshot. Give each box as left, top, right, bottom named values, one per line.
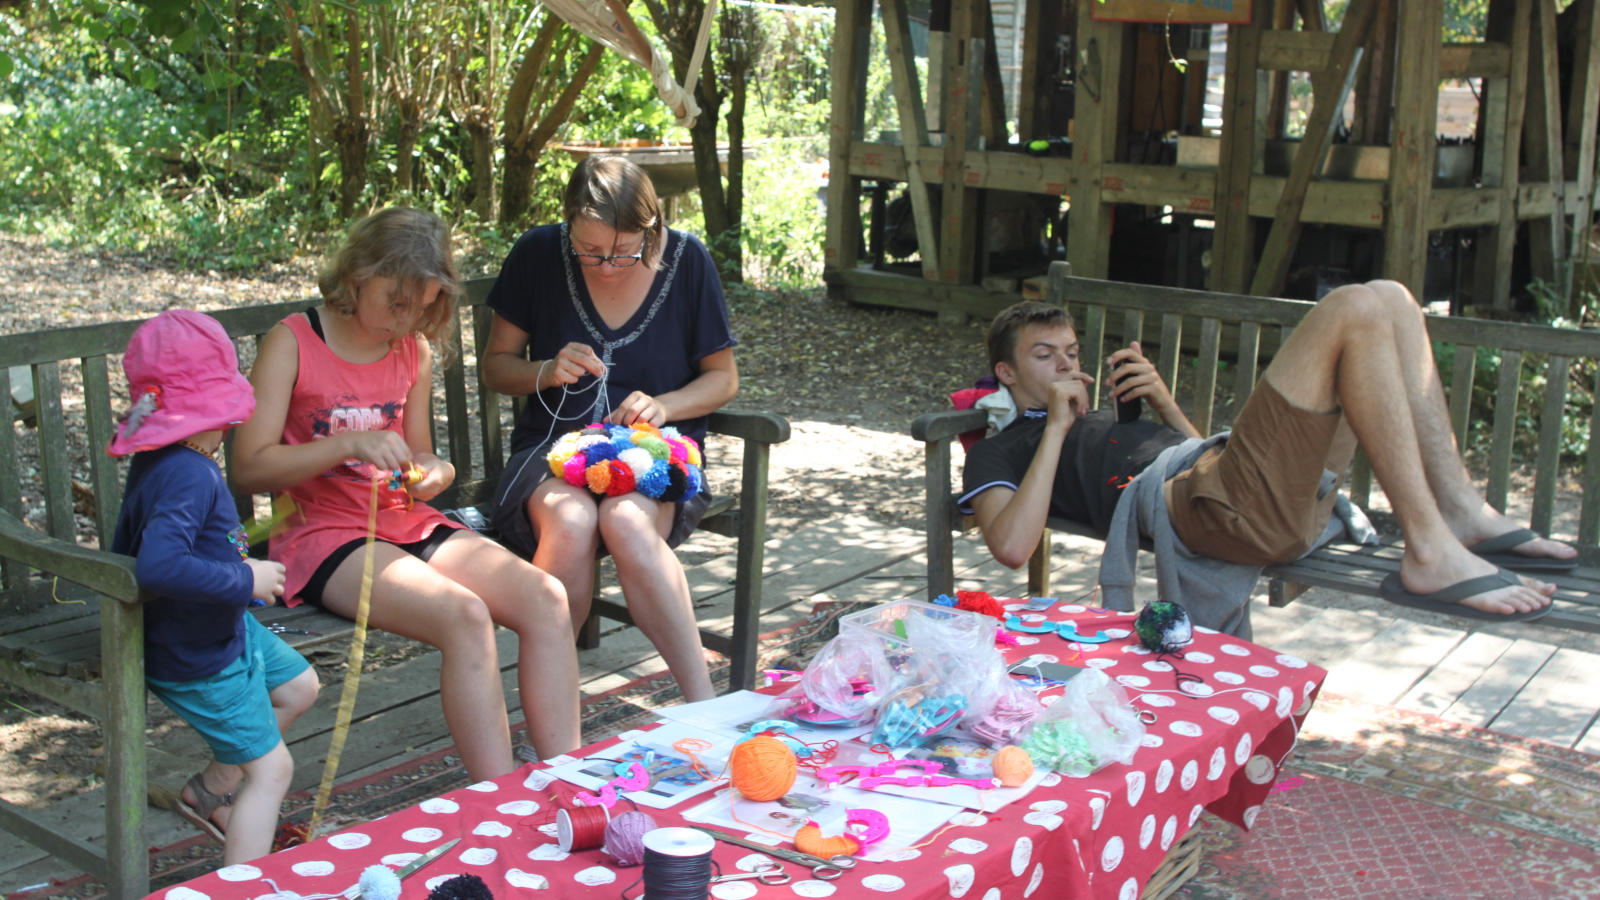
left=1067, top=8, right=1128, bottom=279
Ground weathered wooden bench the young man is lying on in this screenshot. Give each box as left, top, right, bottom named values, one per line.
left=910, top=263, right=1600, bottom=631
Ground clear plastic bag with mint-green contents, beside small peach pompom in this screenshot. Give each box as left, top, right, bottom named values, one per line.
left=1019, top=669, right=1144, bottom=775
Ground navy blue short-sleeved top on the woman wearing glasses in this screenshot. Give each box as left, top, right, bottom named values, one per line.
left=488, top=224, right=736, bottom=453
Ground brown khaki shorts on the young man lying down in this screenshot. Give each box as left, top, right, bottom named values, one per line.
left=1166, top=378, right=1341, bottom=565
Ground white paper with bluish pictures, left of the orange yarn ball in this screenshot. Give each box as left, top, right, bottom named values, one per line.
left=547, top=722, right=733, bottom=809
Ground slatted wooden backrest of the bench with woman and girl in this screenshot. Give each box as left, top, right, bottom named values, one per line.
left=0, top=279, right=496, bottom=591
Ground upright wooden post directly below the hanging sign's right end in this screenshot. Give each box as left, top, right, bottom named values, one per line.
left=1209, top=13, right=1266, bottom=293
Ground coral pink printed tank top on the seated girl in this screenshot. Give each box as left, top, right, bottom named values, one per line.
left=270, top=314, right=454, bottom=607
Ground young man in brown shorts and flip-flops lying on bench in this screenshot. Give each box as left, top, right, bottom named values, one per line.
left=960, top=282, right=1576, bottom=637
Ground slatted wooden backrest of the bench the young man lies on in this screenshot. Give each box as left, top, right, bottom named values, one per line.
left=1048, top=263, right=1600, bottom=546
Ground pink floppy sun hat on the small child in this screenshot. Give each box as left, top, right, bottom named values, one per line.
left=106, top=309, right=256, bottom=456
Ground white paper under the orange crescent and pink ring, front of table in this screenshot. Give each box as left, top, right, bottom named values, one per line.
left=683, top=773, right=965, bottom=863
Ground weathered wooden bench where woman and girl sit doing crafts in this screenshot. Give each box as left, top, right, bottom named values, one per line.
left=0, top=279, right=789, bottom=897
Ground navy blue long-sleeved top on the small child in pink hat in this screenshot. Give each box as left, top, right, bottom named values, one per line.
left=112, top=444, right=254, bottom=681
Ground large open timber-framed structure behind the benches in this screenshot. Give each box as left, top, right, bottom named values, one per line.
left=824, top=0, right=1600, bottom=317
